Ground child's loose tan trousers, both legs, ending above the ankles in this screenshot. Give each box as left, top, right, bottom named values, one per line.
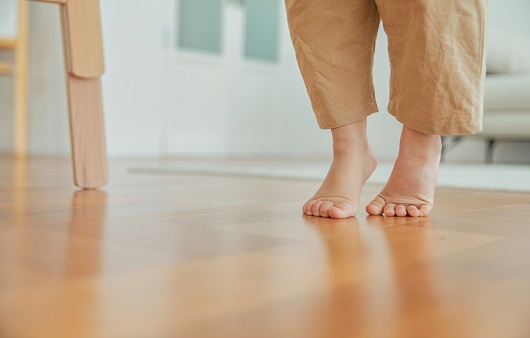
left=286, top=0, right=487, bottom=135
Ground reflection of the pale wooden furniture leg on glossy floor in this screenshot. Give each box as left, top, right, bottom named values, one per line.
left=50, top=190, right=107, bottom=336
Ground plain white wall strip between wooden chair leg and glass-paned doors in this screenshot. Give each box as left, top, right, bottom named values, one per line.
left=100, top=0, right=164, bottom=155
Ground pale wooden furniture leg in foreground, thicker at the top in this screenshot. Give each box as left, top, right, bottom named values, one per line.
left=61, top=0, right=108, bottom=189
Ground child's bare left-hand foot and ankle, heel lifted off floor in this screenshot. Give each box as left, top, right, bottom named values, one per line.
left=302, top=119, right=377, bottom=218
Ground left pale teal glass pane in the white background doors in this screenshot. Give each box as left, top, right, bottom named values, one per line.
left=177, top=0, right=222, bottom=53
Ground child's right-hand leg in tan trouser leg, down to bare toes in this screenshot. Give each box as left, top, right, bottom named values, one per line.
left=366, top=0, right=487, bottom=216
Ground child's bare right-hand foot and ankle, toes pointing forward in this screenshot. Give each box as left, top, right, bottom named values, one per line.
left=366, top=126, right=442, bottom=217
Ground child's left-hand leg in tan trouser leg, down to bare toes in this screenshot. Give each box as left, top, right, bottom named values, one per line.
left=286, top=0, right=380, bottom=218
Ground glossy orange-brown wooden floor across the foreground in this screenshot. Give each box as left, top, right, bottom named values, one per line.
left=0, top=156, right=530, bottom=338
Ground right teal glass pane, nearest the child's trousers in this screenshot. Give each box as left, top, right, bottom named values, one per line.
left=245, top=0, right=280, bottom=61
